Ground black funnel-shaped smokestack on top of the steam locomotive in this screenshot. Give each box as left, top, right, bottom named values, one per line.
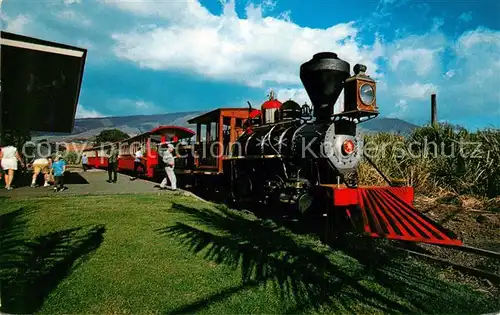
left=300, top=52, right=350, bottom=121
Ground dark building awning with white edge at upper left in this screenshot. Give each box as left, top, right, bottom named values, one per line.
left=0, top=32, right=87, bottom=133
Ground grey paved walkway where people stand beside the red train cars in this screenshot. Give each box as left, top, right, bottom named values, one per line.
left=0, top=170, right=200, bottom=198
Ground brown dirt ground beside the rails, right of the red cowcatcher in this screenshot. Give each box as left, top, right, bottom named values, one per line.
left=415, top=193, right=500, bottom=296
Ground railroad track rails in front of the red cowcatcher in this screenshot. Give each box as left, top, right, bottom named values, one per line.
left=396, top=244, right=500, bottom=284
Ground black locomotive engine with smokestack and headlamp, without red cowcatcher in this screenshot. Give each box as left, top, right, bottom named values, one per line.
left=231, top=52, right=378, bottom=212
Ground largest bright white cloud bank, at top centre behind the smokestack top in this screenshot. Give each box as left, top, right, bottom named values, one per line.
left=108, top=0, right=382, bottom=87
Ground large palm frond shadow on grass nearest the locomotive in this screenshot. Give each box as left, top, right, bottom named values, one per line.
left=160, top=204, right=408, bottom=314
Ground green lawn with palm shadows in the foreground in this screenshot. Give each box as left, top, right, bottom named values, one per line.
left=0, top=195, right=500, bottom=314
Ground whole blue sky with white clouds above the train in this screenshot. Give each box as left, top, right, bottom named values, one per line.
left=0, top=0, right=500, bottom=130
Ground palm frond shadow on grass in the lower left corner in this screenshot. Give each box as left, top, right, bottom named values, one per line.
left=0, top=208, right=105, bottom=314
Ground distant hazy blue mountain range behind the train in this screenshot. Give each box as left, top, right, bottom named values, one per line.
left=32, top=111, right=419, bottom=141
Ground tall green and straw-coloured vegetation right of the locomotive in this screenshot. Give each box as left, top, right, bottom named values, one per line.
left=360, top=124, right=500, bottom=198
